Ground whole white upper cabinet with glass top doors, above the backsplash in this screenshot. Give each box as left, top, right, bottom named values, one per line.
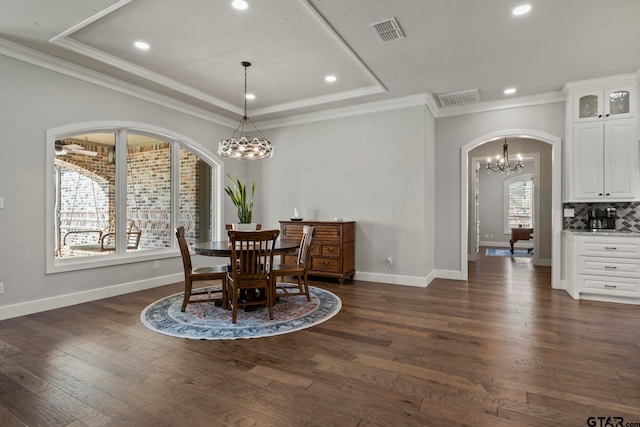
left=564, top=75, right=640, bottom=202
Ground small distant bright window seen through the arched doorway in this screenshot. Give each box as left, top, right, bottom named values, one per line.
left=503, top=174, right=533, bottom=234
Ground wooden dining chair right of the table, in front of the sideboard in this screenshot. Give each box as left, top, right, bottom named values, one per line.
left=271, top=225, right=314, bottom=301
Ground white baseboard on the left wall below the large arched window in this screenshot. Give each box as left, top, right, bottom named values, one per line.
left=0, top=273, right=184, bottom=320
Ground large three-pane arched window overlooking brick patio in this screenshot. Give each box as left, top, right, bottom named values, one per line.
left=47, top=125, right=223, bottom=273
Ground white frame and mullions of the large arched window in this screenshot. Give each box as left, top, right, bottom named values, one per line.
left=44, top=121, right=225, bottom=274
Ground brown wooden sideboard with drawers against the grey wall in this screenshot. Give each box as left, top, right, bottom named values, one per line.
left=280, top=221, right=356, bottom=285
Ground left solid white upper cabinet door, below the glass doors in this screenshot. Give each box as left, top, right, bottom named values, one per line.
left=573, top=122, right=604, bottom=200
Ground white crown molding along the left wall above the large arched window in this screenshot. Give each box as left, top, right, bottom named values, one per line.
left=0, top=38, right=238, bottom=129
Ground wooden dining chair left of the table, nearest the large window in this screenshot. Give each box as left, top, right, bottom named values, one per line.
left=176, top=226, right=227, bottom=311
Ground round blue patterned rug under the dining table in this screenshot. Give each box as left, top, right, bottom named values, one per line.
left=140, top=285, right=342, bottom=340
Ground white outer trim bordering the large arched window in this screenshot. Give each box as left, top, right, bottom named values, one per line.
left=45, top=121, right=225, bottom=274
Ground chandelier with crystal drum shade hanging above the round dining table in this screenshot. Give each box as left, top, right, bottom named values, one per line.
left=218, top=61, right=273, bottom=160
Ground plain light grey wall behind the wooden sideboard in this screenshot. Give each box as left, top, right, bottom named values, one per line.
left=249, top=106, right=434, bottom=286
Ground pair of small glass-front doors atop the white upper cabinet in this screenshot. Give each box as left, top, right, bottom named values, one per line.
left=574, top=86, right=632, bottom=122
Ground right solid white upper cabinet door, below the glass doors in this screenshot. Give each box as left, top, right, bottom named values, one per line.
left=604, top=120, right=638, bottom=200
